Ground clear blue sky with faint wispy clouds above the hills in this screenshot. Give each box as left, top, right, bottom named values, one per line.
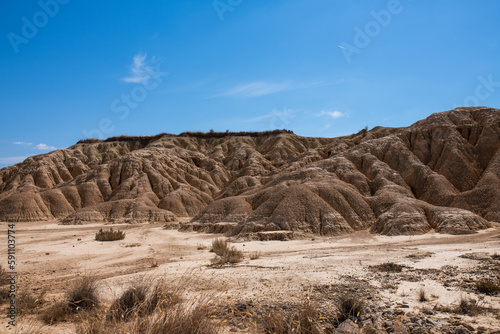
left=0, top=0, right=500, bottom=167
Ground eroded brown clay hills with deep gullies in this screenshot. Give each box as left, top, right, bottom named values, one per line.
left=0, top=108, right=500, bottom=235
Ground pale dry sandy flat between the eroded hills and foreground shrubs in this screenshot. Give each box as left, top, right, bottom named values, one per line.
left=0, top=221, right=500, bottom=333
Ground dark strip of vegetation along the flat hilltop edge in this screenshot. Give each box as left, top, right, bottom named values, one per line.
left=77, top=129, right=293, bottom=144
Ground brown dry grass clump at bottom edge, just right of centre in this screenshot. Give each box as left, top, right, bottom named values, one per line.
left=260, top=299, right=322, bottom=334
